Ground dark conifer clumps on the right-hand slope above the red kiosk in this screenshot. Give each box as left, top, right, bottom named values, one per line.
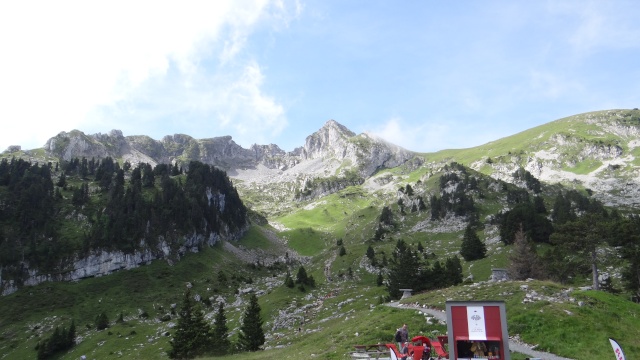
left=380, top=163, right=640, bottom=300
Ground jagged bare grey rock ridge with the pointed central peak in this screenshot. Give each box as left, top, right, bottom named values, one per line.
left=44, top=120, right=414, bottom=176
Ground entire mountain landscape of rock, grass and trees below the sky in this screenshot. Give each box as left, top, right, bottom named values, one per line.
left=0, top=109, right=640, bottom=360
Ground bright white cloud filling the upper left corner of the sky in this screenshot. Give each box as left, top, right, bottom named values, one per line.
left=0, top=0, right=296, bottom=151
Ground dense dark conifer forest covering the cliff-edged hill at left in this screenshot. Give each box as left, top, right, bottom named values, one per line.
left=0, top=157, right=248, bottom=282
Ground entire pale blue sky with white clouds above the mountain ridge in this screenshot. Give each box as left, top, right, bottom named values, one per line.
left=0, top=0, right=640, bottom=152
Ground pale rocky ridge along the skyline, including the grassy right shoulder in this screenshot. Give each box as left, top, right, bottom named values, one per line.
left=10, top=109, right=640, bottom=207
